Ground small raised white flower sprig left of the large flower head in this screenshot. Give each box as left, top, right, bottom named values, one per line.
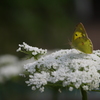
left=17, top=42, right=47, bottom=56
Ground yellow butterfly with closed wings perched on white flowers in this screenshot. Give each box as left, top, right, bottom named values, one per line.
left=72, top=23, right=93, bottom=54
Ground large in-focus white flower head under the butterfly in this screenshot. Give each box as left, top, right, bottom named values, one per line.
left=24, top=49, right=100, bottom=92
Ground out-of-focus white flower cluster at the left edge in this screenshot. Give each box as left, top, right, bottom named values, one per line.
left=0, top=54, right=33, bottom=84
